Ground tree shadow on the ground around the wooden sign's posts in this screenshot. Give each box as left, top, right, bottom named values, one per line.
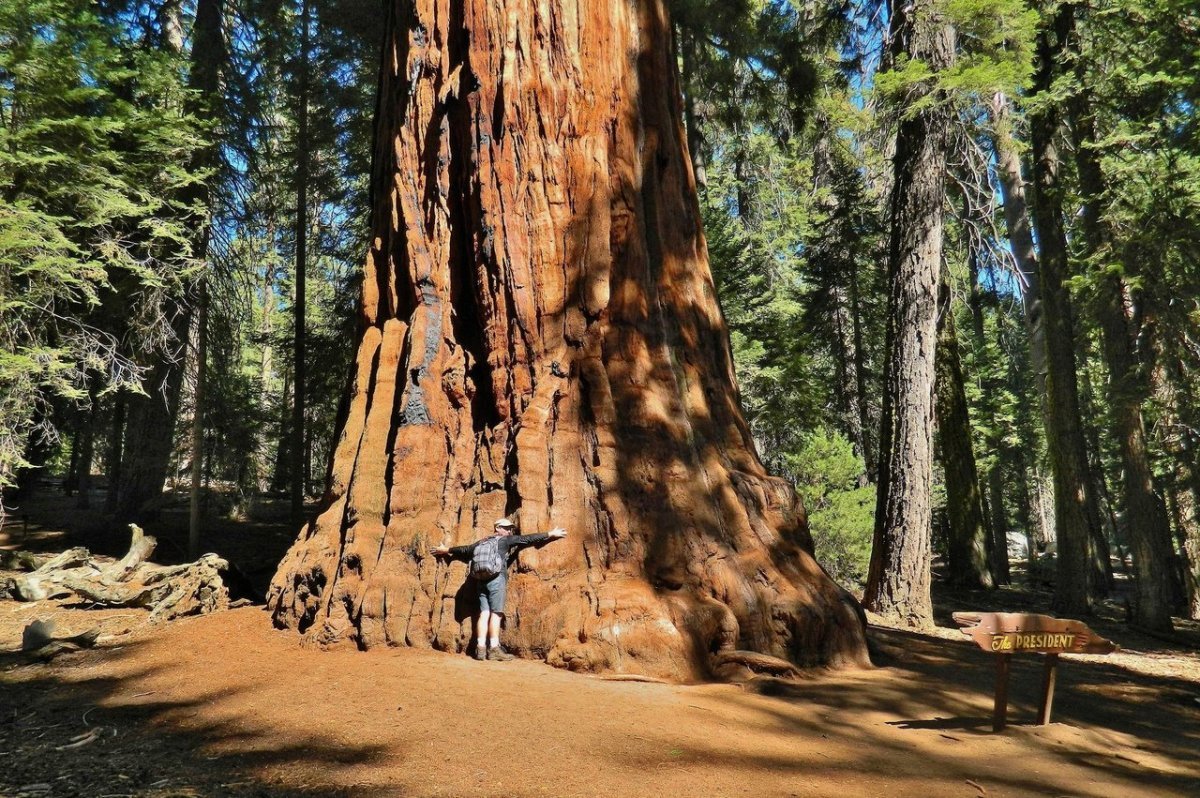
left=600, top=628, right=1200, bottom=798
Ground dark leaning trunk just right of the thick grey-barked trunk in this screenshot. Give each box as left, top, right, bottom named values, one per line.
left=936, top=280, right=996, bottom=589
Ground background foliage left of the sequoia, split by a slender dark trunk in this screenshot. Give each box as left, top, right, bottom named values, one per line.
left=188, top=0, right=369, bottom=497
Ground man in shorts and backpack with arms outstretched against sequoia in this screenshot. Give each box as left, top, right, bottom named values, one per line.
left=433, top=518, right=566, bottom=661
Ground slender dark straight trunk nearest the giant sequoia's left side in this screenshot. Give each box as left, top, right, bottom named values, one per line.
left=292, top=0, right=311, bottom=523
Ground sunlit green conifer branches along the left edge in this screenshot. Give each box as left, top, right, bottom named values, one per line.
left=0, top=0, right=202, bottom=486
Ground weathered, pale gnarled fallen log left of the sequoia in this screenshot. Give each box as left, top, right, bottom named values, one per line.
left=0, top=523, right=229, bottom=623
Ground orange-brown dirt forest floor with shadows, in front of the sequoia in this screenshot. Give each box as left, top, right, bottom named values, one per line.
left=0, top=489, right=1200, bottom=798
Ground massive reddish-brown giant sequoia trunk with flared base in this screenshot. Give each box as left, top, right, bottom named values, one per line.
left=269, top=0, right=865, bottom=678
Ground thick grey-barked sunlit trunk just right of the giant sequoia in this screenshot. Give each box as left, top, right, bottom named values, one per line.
left=864, top=2, right=954, bottom=625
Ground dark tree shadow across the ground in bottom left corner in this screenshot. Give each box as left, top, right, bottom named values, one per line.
left=0, top=633, right=393, bottom=798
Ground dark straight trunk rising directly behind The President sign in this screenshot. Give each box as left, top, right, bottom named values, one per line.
left=1030, top=2, right=1100, bottom=614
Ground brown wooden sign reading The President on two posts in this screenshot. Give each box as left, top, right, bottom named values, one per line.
left=954, top=612, right=1117, bottom=732
